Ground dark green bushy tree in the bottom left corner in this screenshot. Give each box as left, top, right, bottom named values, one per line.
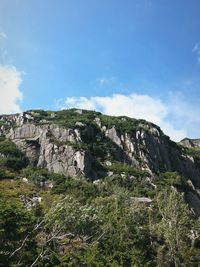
left=0, top=202, right=36, bottom=266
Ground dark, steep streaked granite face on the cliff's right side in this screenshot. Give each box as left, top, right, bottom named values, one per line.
left=106, top=127, right=200, bottom=186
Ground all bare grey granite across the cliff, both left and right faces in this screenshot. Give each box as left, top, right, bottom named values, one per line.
left=0, top=112, right=200, bottom=186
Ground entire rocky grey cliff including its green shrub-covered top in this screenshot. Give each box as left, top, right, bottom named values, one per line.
left=0, top=109, right=200, bottom=186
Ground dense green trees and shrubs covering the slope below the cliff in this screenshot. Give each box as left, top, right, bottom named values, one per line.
left=0, top=158, right=200, bottom=267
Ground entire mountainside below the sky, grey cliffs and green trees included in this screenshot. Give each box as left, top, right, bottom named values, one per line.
left=0, top=109, right=200, bottom=266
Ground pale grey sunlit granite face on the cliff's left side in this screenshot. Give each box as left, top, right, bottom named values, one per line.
left=3, top=123, right=91, bottom=179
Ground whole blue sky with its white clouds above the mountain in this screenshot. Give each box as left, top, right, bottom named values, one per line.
left=0, top=0, right=200, bottom=141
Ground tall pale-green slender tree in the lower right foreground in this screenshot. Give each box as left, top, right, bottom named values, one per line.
left=153, top=190, right=196, bottom=267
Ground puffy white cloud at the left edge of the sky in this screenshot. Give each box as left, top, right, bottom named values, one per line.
left=0, top=65, right=23, bottom=114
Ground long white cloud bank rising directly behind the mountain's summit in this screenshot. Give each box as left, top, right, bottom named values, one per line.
left=60, top=94, right=187, bottom=141
